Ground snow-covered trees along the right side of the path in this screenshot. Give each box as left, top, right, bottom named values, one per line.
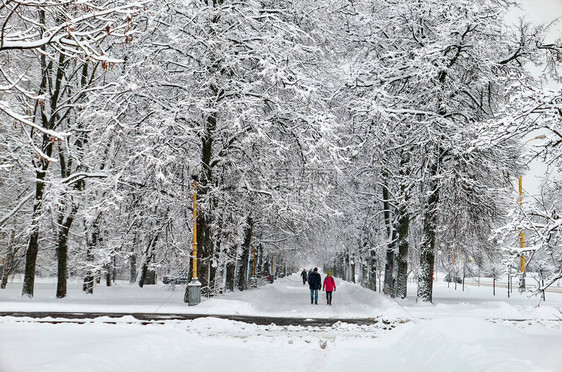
left=320, top=1, right=560, bottom=301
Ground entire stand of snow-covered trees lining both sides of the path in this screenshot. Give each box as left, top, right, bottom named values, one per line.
left=0, top=0, right=559, bottom=301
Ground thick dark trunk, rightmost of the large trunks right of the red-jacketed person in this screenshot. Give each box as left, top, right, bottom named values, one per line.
left=417, top=164, right=439, bottom=302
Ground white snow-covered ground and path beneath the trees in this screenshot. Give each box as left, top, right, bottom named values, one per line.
left=0, top=275, right=562, bottom=372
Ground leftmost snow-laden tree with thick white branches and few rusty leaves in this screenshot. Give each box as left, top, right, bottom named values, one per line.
left=0, top=1, right=147, bottom=297
